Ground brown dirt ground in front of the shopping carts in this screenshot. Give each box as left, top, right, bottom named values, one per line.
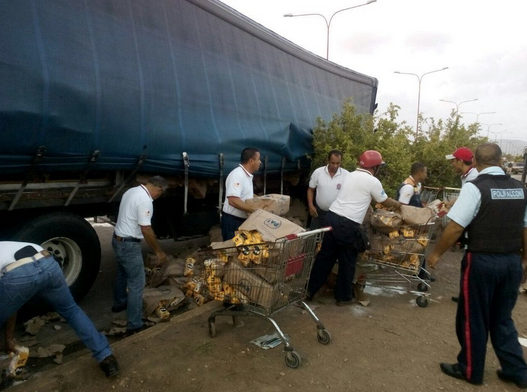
left=4, top=243, right=527, bottom=392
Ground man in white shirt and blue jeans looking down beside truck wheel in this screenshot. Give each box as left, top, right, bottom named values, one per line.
left=112, top=176, right=168, bottom=336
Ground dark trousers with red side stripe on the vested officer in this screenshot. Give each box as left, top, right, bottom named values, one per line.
left=456, top=251, right=527, bottom=382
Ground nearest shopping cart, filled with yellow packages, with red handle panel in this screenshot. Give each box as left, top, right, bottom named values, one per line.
left=198, top=227, right=331, bottom=368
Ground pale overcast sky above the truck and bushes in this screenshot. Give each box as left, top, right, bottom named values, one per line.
left=223, top=0, right=527, bottom=150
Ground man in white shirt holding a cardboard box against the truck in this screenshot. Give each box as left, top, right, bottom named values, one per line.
left=221, top=147, right=262, bottom=241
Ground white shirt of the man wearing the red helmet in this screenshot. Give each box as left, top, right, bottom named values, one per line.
left=329, top=169, right=388, bottom=224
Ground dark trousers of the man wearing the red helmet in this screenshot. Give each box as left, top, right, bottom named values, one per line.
left=307, top=211, right=362, bottom=301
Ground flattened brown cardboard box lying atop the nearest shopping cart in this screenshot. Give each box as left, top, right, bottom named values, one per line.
left=240, top=210, right=305, bottom=242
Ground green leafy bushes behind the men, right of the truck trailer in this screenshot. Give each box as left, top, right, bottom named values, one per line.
left=311, top=100, right=487, bottom=196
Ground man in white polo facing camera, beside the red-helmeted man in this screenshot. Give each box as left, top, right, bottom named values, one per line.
left=307, top=150, right=349, bottom=230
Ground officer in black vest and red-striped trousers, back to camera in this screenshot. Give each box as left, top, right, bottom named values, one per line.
left=428, top=143, right=527, bottom=388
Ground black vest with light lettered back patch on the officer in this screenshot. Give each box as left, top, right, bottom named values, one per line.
left=466, top=174, right=527, bottom=253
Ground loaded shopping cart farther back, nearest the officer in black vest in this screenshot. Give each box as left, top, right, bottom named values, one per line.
left=358, top=220, right=436, bottom=308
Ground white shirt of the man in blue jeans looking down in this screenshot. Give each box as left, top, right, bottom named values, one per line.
left=115, top=185, right=154, bottom=239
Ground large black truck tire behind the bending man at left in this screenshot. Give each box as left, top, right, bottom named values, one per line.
left=13, top=212, right=101, bottom=302
